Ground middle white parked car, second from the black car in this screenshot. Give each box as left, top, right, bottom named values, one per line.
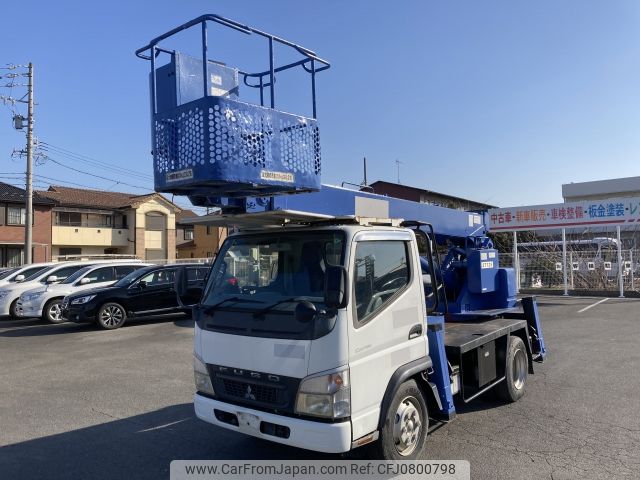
left=0, top=260, right=131, bottom=318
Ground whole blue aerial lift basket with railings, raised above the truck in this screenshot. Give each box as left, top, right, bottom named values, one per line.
left=136, top=15, right=329, bottom=206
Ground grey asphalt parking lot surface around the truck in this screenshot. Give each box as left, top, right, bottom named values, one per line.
left=0, top=297, right=640, bottom=480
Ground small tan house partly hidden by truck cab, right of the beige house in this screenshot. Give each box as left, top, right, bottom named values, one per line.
left=176, top=210, right=227, bottom=258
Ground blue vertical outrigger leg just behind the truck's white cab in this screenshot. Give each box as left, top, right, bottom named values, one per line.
left=427, top=315, right=456, bottom=420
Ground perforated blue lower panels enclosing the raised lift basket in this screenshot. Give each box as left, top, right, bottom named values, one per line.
left=153, top=97, right=321, bottom=197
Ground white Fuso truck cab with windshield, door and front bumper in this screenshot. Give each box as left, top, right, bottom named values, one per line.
left=194, top=225, right=431, bottom=458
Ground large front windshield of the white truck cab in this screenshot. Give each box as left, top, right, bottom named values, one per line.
left=202, top=230, right=344, bottom=338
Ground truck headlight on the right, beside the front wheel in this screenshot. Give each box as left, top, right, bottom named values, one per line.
left=296, top=368, right=351, bottom=418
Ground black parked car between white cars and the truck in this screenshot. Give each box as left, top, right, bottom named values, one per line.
left=62, top=264, right=211, bottom=330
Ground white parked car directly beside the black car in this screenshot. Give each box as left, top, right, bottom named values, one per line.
left=16, top=260, right=148, bottom=323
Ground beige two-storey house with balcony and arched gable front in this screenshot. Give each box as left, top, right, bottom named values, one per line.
left=38, top=186, right=181, bottom=260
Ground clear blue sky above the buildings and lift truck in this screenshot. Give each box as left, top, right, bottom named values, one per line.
left=0, top=0, right=640, bottom=210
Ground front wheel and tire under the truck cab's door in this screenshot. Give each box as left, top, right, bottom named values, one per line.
left=371, top=380, right=429, bottom=460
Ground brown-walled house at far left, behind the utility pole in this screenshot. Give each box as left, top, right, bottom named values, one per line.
left=0, top=182, right=53, bottom=267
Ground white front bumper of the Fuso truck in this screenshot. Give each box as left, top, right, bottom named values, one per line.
left=193, top=393, right=351, bottom=453
